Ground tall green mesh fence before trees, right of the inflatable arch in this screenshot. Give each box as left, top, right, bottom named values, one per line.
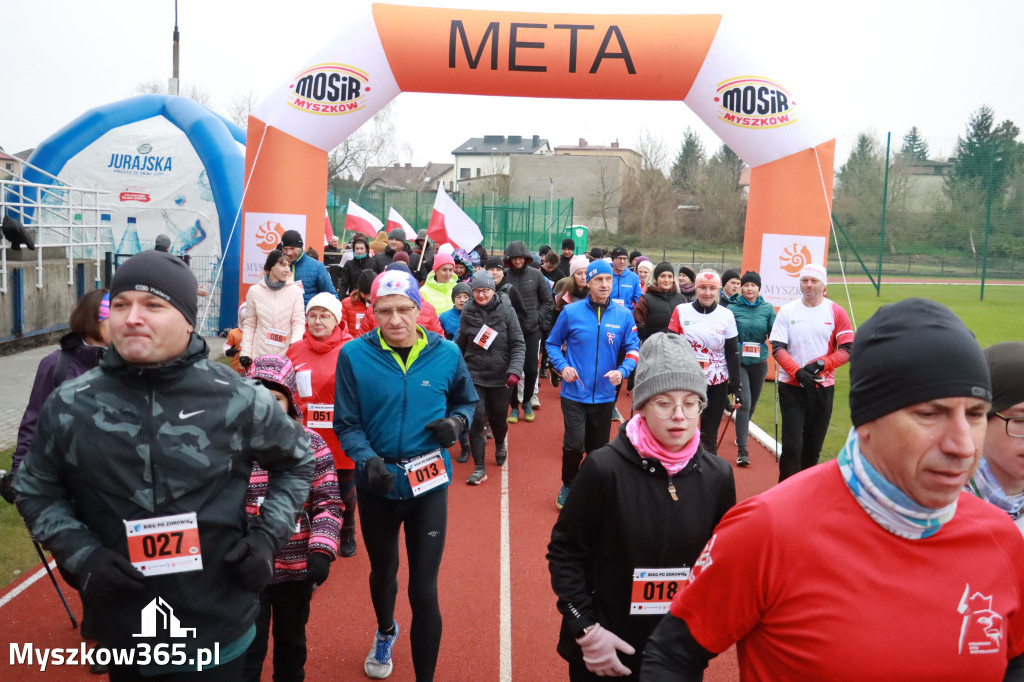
left=829, top=129, right=1024, bottom=288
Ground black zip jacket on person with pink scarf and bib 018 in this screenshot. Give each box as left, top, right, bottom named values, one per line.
left=548, top=424, right=736, bottom=673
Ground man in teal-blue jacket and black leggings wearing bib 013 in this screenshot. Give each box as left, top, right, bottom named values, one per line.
left=334, top=269, right=477, bottom=680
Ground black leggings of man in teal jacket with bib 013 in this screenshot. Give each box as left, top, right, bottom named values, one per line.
left=356, top=486, right=447, bottom=682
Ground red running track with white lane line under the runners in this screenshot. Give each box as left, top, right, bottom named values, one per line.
left=0, top=381, right=778, bottom=682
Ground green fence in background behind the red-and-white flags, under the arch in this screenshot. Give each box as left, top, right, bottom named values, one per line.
left=328, top=189, right=572, bottom=253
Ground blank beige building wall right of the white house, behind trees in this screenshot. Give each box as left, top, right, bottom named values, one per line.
left=509, top=155, right=630, bottom=232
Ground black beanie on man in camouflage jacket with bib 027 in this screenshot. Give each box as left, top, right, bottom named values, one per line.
left=111, top=251, right=199, bottom=327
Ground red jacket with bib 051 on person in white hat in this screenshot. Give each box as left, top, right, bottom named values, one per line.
left=287, top=325, right=355, bottom=469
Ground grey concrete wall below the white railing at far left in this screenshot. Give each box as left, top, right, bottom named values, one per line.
left=0, top=247, right=95, bottom=351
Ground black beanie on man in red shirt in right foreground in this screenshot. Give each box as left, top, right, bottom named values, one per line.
left=850, top=298, right=992, bottom=426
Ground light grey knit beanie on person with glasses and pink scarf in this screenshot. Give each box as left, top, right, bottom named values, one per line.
left=633, top=334, right=708, bottom=411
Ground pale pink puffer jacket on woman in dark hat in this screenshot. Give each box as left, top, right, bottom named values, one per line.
left=241, top=279, right=306, bottom=357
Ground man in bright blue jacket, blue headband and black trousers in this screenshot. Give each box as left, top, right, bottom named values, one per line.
left=546, top=260, right=640, bottom=509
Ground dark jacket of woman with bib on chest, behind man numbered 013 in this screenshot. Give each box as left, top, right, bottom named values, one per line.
left=455, top=294, right=526, bottom=387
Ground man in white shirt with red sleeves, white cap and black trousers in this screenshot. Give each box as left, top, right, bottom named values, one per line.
left=768, top=264, right=853, bottom=482
